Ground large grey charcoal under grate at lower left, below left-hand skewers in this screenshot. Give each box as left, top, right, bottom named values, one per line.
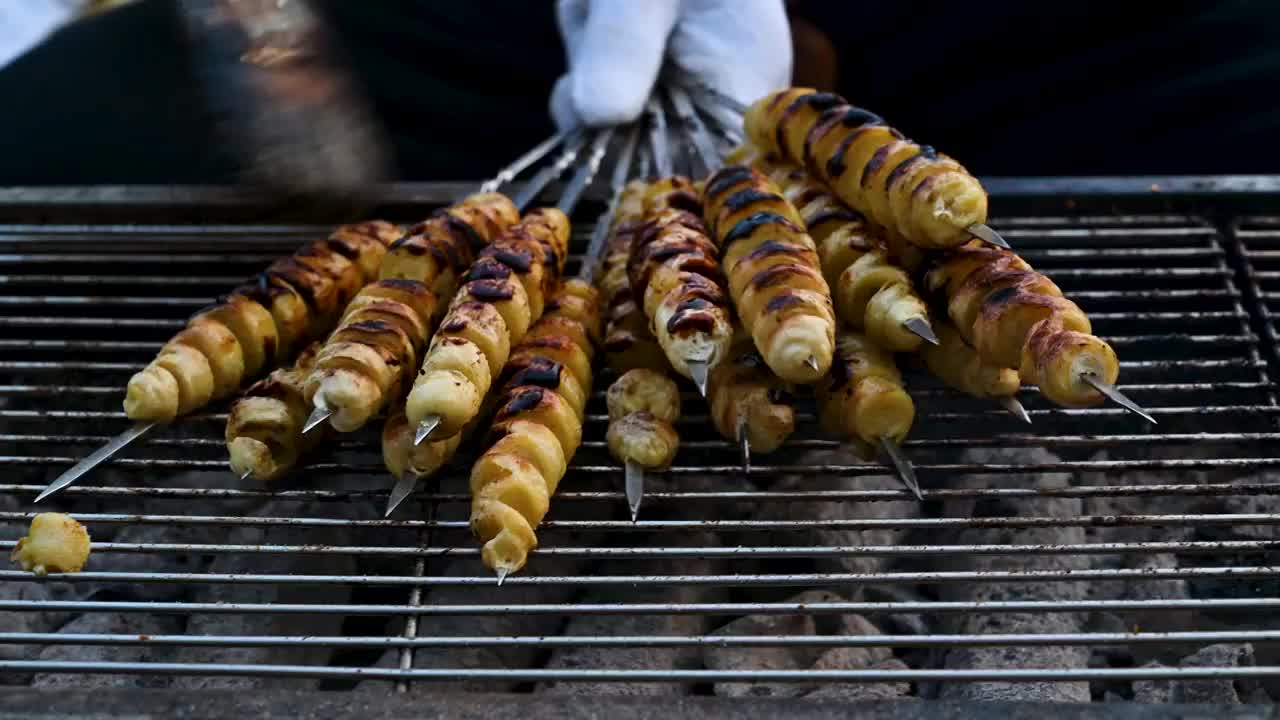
left=173, top=503, right=357, bottom=689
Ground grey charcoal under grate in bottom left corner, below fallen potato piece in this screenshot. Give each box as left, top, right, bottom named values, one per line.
left=32, top=612, right=183, bottom=691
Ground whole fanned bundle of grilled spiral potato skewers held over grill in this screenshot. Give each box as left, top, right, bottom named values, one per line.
left=37, top=78, right=1155, bottom=583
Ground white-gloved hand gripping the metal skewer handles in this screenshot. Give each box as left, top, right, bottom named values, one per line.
left=550, top=0, right=791, bottom=129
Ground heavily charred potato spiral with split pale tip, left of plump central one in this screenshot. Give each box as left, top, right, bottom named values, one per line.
left=627, top=177, right=732, bottom=383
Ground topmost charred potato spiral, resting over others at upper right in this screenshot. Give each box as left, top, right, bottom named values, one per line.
left=744, top=87, right=987, bottom=249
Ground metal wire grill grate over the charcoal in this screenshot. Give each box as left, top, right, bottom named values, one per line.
left=0, top=188, right=1280, bottom=701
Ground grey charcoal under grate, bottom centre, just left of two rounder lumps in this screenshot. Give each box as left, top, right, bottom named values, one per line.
left=535, top=533, right=727, bottom=696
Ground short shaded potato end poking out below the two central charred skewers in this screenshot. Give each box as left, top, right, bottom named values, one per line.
left=707, top=332, right=796, bottom=452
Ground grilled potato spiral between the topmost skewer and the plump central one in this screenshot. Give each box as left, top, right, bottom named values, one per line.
left=752, top=167, right=932, bottom=352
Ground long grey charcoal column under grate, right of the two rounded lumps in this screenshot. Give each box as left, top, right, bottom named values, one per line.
left=938, top=448, right=1092, bottom=702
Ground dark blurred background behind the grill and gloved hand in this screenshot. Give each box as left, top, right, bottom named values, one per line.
left=0, top=0, right=1280, bottom=184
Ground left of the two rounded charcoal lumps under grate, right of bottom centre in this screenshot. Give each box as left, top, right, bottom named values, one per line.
left=703, top=591, right=844, bottom=697
